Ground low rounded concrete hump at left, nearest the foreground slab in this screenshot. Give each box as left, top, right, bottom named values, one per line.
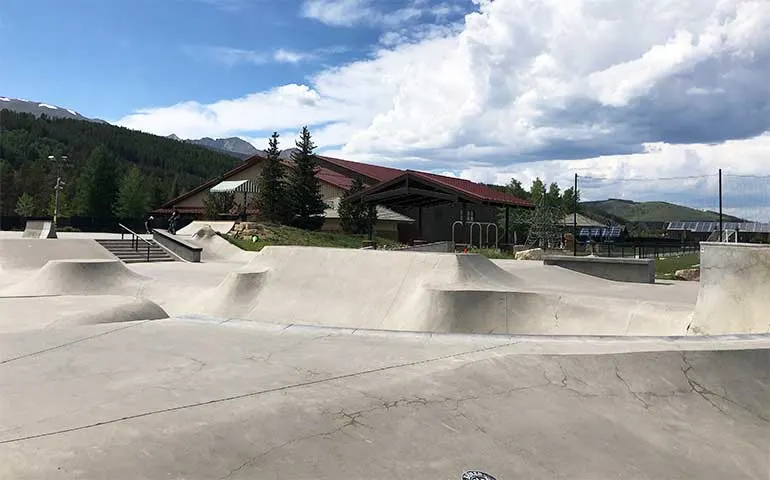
left=0, top=295, right=168, bottom=333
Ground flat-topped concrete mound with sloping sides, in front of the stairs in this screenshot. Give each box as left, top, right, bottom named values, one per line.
left=0, top=260, right=149, bottom=296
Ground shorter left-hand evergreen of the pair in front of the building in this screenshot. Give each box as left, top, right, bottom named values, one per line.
left=257, top=132, right=289, bottom=223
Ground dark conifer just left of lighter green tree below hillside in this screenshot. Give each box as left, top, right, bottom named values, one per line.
left=75, top=145, right=117, bottom=218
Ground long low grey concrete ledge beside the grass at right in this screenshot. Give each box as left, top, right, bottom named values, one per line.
left=543, top=255, right=655, bottom=283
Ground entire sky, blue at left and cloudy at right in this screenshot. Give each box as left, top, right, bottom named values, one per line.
left=0, top=0, right=770, bottom=219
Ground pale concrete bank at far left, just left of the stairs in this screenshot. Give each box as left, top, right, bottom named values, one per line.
left=0, top=238, right=116, bottom=270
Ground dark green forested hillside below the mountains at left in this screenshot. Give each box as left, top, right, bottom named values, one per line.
left=0, top=110, right=240, bottom=218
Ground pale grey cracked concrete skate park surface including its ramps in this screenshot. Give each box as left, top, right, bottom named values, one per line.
left=0, top=232, right=770, bottom=480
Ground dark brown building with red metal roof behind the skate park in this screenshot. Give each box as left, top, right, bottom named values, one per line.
left=155, top=155, right=533, bottom=243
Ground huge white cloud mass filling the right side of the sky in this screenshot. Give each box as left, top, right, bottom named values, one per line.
left=119, top=0, right=770, bottom=215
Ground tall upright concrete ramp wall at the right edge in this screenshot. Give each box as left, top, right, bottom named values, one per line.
left=690, top=242, right=770, bottom=335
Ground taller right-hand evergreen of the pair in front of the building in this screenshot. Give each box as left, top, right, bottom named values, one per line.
left=288, top=127, right=326, bottom=230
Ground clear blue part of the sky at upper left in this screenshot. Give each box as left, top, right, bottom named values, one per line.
left=0, top=0, right=420, bottom=118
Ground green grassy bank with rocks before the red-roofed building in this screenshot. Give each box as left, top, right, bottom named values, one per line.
left=216, top=224, right=398, bottom=251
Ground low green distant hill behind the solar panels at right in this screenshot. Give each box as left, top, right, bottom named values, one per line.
left=581, top=198, right=743, bottom=224
